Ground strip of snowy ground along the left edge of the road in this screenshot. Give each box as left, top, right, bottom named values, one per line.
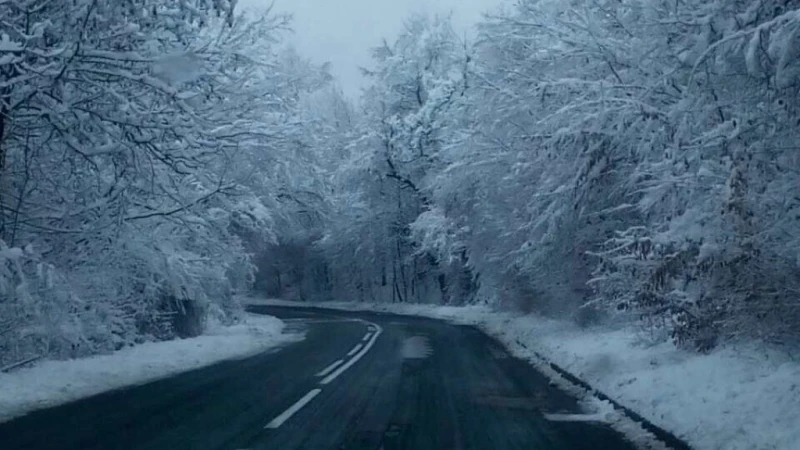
left=0, top=314, right=302, bottom=422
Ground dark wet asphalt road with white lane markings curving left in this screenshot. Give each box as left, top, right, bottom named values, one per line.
left=0, top=307, right=644, bottom=450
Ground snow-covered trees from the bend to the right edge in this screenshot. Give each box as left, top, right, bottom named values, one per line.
left=270, top=0, right=800, bottom=350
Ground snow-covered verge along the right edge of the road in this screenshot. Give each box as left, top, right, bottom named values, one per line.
left=250, top=300, right=800, bottom=450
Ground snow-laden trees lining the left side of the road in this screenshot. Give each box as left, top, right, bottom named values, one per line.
left=0, top=0, right=330, bottom=367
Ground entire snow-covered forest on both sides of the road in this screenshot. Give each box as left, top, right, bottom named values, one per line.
left=0, top=0, right=800, bottom=367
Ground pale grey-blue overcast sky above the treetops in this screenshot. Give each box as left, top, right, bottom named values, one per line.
left=239, top=0, right=508, bottom=97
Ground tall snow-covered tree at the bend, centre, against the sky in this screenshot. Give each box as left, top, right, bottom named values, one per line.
left=321, top=16, right=482, bottom=303
